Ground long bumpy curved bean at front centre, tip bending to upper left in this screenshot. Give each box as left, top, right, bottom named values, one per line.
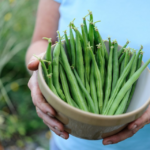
left=88, top=46, right=103, bottom=113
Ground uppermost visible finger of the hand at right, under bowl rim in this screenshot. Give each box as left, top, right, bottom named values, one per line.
left=128, top=106, right=150, bottom=130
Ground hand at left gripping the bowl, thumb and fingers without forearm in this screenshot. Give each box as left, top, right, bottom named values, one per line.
left=28, top=53, right=69, bottom=139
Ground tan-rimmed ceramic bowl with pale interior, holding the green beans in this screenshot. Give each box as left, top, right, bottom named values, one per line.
left=38, top=41, right=150, bottom=140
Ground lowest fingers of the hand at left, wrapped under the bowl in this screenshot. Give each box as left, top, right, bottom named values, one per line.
left=36, top=107, right=69, bottom=139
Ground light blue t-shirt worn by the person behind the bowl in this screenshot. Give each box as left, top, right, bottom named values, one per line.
left=52, top=0, right=150, bottom=150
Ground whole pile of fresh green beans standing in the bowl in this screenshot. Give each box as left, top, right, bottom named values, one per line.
left=38, top=11, right=150, bottom=115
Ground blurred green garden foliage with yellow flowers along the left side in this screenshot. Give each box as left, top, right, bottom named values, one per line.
left=0, top=0, right=50, bottom=150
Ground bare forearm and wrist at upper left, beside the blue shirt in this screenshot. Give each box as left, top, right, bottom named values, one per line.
left=26, top=0, right=60, bottom=65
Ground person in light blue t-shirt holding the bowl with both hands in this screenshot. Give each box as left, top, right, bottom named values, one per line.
left=26, top=0, right=150, bottom=150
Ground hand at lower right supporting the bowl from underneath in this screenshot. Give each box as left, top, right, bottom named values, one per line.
left=103, top=105, right=150, bottom=145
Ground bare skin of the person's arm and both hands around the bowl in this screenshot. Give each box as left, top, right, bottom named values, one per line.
left=26, top=0, right=150, bottom=145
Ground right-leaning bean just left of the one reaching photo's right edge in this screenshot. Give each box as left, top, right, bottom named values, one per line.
left=103, top=52, right=136, bottom=115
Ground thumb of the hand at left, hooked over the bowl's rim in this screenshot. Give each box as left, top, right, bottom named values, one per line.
left=27, top=53, right=45, bottom=71
